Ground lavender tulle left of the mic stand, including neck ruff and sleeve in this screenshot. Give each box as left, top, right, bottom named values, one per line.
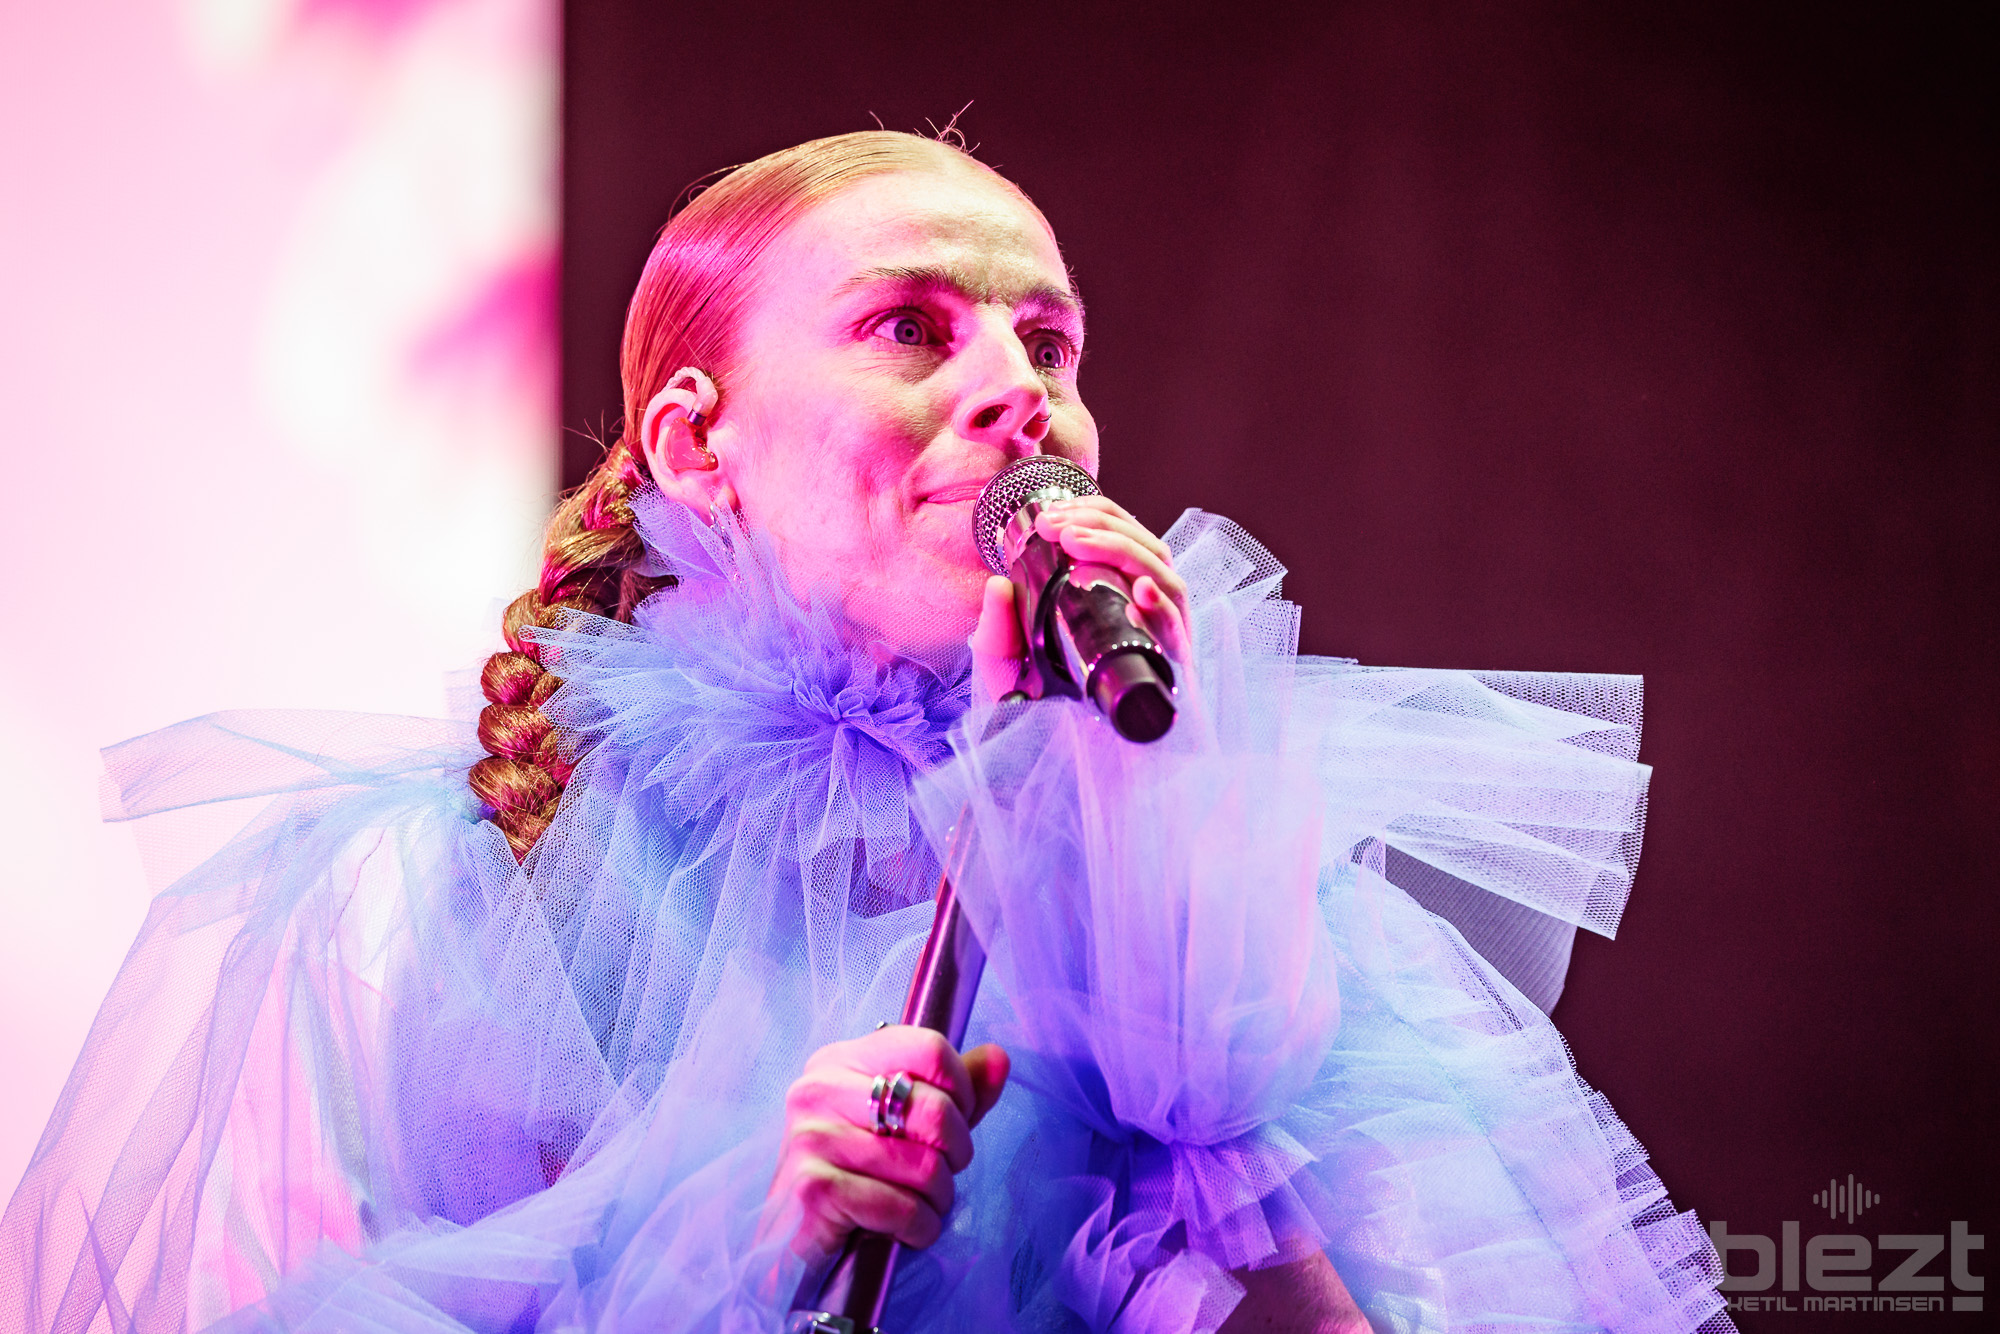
left=0, top=498, right=966, bottom=1334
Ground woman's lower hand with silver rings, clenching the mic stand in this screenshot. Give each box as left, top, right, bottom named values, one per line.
left=766, top=1024, right=1008, bottom=1262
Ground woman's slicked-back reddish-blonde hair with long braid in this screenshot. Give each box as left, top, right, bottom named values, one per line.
left=470, top=130, right=1012, bottom=858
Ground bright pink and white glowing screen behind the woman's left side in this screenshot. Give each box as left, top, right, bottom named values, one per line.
left=0, top=0, right=558, bottom=1192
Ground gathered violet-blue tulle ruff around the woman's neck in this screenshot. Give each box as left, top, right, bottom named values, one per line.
left=530, top=488, right=968, bottom=892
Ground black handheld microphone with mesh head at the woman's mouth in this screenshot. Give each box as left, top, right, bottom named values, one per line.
left=972, top=454, right=1174, bottom=742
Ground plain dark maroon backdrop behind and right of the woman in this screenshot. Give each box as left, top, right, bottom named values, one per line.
left=564, top=0, right=2000, bottom=1330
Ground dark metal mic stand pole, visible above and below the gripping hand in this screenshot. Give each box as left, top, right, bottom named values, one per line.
left=786, top=812, right=986, bottom=1334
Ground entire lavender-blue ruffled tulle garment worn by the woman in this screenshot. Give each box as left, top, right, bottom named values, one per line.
left=0, top=496, right=1726, bottom=1334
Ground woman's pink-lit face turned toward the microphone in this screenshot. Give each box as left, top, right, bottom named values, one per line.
left=682, top=166, right=1098, bottom=652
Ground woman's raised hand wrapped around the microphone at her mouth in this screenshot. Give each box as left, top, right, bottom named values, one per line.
left=970, top=496, right=1188, bottom=698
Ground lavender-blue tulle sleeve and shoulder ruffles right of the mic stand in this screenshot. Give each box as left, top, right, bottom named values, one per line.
left=920, top=512, right=1720, bottom=1330
